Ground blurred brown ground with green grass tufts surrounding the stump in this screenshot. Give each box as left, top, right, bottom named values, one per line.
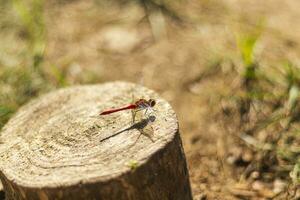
left=0, top=0, right=300, bottom=200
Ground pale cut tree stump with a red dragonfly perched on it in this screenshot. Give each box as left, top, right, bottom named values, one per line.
left=0, top=82, right=192, bottom=200
